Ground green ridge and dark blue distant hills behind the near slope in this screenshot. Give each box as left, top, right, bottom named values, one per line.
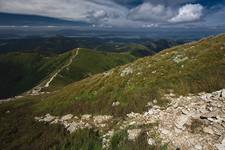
left=0, top=37, right=182, bottom=99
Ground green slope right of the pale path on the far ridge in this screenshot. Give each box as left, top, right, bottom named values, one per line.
left=46, top=48, right=136, bottom=90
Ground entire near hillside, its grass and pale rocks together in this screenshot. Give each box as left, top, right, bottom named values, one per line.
left=0, top=35, right=225, bottom=150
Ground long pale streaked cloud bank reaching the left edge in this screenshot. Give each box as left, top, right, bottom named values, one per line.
left=0, top=0, right=127, bottom=21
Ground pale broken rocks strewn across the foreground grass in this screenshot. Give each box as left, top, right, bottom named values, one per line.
left=35, top=89, right=225, bottom=150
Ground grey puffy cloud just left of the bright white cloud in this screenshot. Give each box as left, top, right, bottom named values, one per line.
left=128, top=2, right=173, bottom=22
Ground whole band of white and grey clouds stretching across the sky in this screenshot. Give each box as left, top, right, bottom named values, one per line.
left=0, top=0, right=209, bottom=27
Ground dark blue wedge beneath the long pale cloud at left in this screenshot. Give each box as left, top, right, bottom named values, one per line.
left=0, top=13, right=89, bottom=26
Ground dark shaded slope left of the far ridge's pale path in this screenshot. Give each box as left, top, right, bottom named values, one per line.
left=0, top=52, right=70, bottom=98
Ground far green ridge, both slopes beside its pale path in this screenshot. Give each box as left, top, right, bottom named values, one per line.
left=0, top=49, right=136, bottom=99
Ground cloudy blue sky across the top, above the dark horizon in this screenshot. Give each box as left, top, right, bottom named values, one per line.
left=0, top=0, right=225, bottom=28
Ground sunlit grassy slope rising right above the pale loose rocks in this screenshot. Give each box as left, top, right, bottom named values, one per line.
left=36, top=35, right=225, bottom=115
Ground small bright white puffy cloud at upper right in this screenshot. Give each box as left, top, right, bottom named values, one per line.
left=169, top=4, right=204, bottom=23
